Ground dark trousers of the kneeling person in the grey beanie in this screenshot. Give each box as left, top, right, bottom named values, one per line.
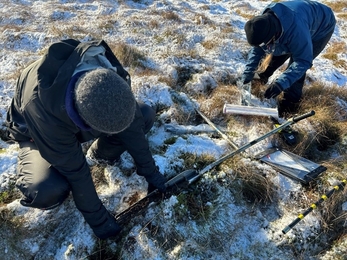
left=16, top=103, right=155, bottom=209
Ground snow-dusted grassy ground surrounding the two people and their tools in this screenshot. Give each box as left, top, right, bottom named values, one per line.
left=0, top=0, right=347, bottom=259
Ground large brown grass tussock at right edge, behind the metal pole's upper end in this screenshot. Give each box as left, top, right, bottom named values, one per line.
left=284, top=81, right=347, bottom=162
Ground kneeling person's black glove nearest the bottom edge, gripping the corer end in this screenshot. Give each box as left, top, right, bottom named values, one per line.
left=91, top=212, right=122, bottom=239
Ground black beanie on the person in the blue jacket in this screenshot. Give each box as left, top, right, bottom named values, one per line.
left=244, top=13, right=277, bottom=46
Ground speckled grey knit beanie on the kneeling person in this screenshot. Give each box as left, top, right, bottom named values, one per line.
left=75, top=69, right=136, bottom=134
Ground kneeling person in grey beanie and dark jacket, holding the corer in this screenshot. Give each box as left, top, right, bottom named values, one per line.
left=6, top=39, right=166, bottom=239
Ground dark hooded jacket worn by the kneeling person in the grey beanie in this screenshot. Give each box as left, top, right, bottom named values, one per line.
left=7, top=39, right=155, bottom=226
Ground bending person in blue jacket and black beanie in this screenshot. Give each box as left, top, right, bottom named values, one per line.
left=241, top=0, right=336, bottom=117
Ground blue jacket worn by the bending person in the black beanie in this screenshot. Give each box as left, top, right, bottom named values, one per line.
left=244, top=0, right=336, bottom=90
